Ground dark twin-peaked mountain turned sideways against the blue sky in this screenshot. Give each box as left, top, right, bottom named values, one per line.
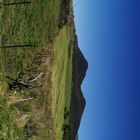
left=70, top=44, right=88, bottom=140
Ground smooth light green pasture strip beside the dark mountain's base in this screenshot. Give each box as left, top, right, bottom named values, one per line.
left=52, top=27, right=72, bottom=140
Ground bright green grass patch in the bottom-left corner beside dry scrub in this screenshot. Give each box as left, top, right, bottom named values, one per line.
left=0, top=96, right=23, bottom=140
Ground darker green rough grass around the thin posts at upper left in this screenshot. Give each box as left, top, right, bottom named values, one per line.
left=0, top=0, right=60, bottom=77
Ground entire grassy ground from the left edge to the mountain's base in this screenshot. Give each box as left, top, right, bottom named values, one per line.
left=0, top=0, right=73, bottom=140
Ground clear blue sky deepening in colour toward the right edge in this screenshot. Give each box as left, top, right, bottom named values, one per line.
left=74, top=0, right=140, bottom=140
